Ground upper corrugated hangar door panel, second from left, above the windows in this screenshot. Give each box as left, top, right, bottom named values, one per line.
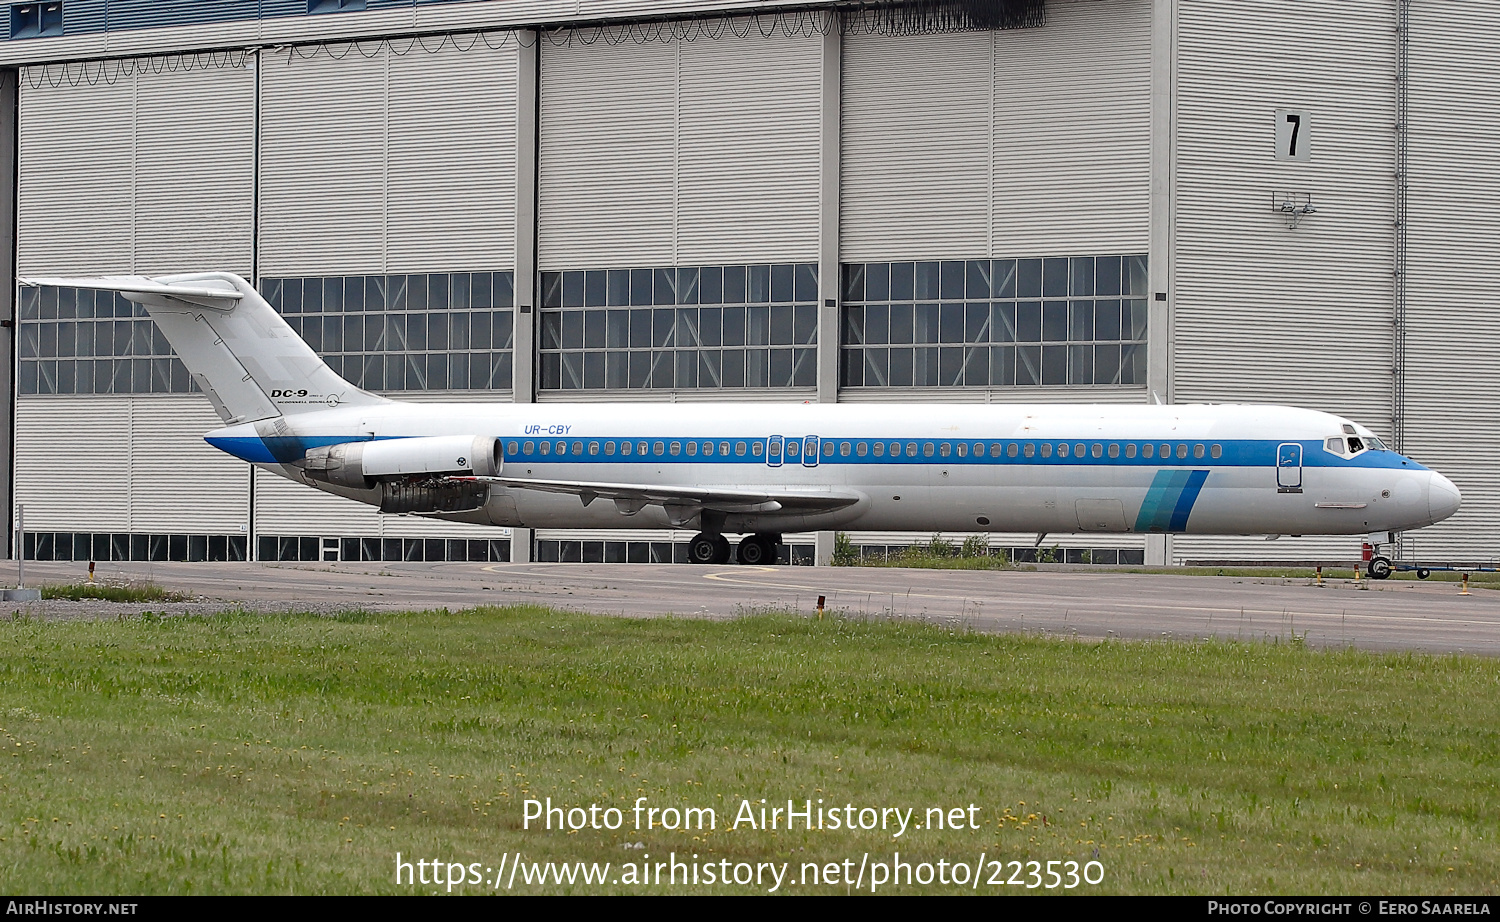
left=261, top=36, right=516, bottom=276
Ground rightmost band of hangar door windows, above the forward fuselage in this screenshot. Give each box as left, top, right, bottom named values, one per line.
left=840, top=255, right=1148, bottom=387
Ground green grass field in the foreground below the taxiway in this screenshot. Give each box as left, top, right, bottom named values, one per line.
left=0, top=609, right=1500, bottom=894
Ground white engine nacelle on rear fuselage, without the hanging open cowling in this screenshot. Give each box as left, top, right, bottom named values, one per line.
left=300, top=435, right=504, bottom=494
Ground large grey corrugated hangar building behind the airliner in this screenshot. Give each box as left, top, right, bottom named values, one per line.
left=0, top=0, right=1500, bottom=562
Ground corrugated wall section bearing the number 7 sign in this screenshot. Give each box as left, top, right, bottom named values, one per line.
left=1172, top=0, right=1397, bottom=559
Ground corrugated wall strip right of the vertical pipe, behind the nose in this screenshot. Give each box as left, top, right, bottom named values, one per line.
left=1406, top=0, right=1500, bottom=559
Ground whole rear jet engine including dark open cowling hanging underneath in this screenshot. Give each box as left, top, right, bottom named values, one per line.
left=299, top=435, right=504, bottom=514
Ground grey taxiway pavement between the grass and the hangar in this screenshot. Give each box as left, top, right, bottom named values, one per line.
left=6, top=562, right=1500, bottom=655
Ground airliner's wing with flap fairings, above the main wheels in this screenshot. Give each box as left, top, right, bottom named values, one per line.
left=468, top=477, right=863, bottom=523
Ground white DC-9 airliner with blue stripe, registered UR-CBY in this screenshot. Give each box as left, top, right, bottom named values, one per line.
left=23, top=273, right=1461, bottom=576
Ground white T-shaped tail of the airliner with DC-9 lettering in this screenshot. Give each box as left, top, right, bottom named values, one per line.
left=20, top=273, right=387, bottom=426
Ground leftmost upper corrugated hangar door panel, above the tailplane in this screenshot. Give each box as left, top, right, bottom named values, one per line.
left=18, top=57, right=255, bottom=274
